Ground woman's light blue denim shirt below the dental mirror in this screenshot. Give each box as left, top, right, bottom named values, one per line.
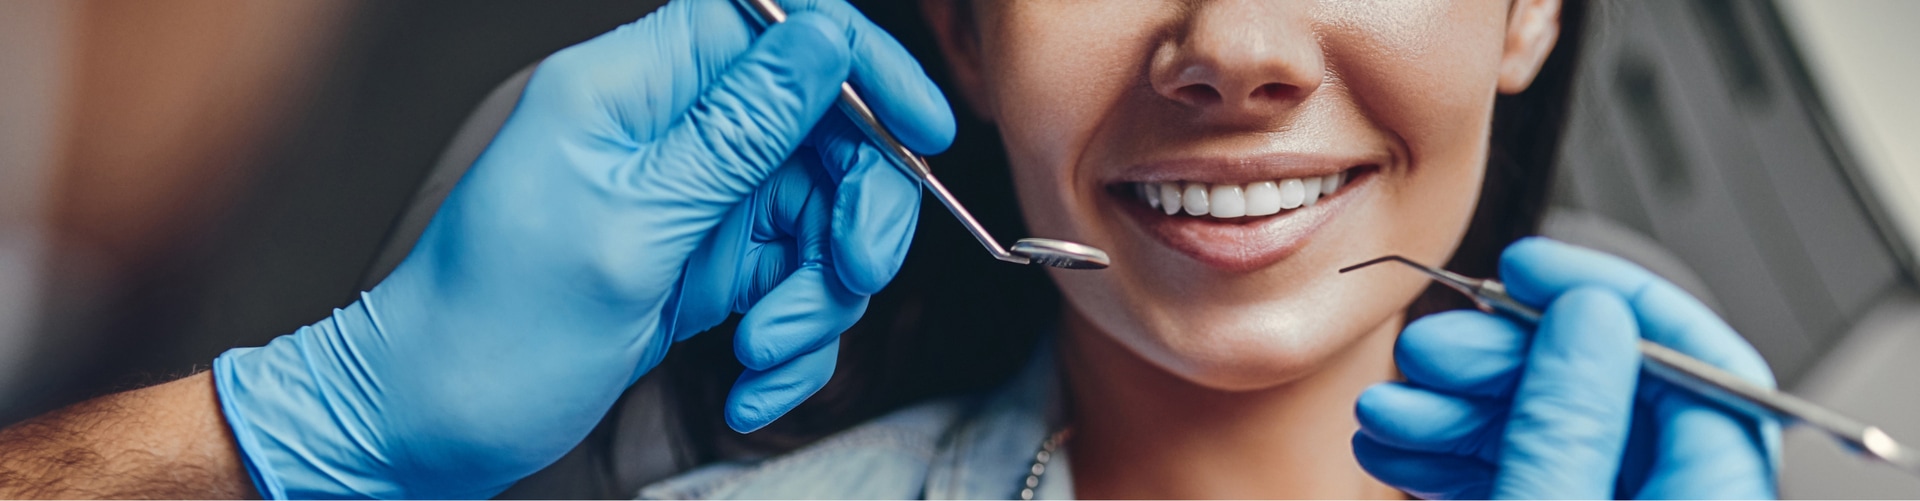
left=639, top=344, right=1073, bottom=499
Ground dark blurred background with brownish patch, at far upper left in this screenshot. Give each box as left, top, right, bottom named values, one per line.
left=0, top=0, right=657, bottom=416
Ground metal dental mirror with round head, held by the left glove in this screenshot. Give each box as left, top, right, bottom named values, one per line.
left=743, top=0, right=1110, bottom=269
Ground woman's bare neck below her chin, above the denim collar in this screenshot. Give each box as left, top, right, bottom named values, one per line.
left=1060, top=313, right=1405, bottom=499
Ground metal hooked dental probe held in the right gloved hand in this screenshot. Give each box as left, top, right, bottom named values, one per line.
left=1340, top=255, right=1920, bottom=476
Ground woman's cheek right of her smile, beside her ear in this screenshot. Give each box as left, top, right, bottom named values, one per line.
left=1323, top=2, right=1505, bottom=249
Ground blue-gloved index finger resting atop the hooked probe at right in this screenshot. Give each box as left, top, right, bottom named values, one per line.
left=1500, top=238, right=1774, bottom=386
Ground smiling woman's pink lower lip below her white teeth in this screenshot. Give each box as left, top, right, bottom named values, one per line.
left=1114, top=167, right=1377, bottom=273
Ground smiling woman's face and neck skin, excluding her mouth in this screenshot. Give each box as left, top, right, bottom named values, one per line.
left=924, top=0, right=1561, bottom=499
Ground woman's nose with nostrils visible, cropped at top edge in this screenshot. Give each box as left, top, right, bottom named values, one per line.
left=1150, top=0, right=1327, bottom=119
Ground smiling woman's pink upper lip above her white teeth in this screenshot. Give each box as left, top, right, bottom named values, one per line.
left=1108, top=154, right=1386, bottom=184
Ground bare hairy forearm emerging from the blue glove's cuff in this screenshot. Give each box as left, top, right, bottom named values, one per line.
left=0, top=372, right=255, bottom=499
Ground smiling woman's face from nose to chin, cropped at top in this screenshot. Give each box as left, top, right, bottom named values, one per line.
left=931, top=0, right=1559, bottom=390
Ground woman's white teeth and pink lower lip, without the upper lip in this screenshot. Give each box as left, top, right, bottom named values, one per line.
left=1108, top=165, right=1380, bottom=273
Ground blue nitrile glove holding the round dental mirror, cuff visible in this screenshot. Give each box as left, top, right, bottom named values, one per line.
left=213, top=0, right=954, bottom=499
